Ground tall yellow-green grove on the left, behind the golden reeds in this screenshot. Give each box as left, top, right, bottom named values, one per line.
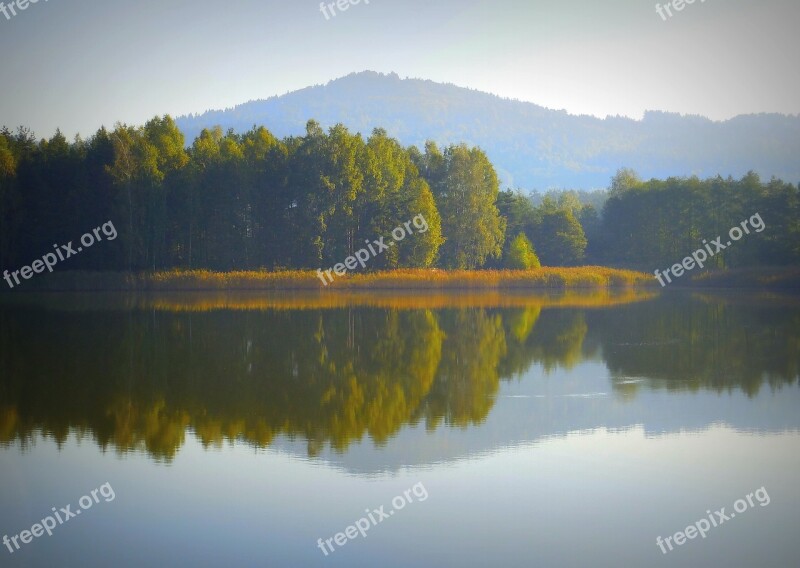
left=0, top=117, right=505, bottom=270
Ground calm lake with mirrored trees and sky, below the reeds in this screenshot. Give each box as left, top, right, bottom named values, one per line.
left=0, top=290, right=800, bottom=568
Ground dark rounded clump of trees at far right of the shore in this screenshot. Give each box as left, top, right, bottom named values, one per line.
left=594, top=170, right=800, bottom=268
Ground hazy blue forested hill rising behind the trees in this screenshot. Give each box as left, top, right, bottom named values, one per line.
left=176, top=71, right=800, bottom=189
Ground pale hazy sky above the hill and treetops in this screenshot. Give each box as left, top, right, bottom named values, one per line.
left=0, top=0, right=800, bottom=137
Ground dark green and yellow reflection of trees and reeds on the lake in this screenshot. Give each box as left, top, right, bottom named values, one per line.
left=0, top=291, right=800, bottom=461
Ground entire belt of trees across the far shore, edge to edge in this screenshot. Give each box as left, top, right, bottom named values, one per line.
left=0, top=116, right=800, bottom=271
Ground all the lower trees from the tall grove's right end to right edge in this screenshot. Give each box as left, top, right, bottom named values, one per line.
left=498, top=168, right=800, bottom=271
